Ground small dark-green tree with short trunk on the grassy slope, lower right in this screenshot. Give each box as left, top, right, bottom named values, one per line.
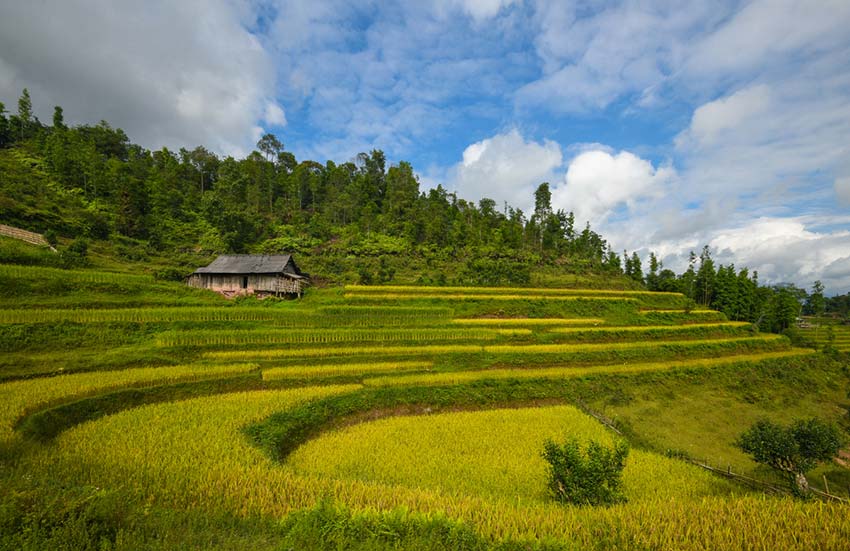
left=735, top=418, right=842, bottom=495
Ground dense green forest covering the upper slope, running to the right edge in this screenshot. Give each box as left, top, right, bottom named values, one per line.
left=0, top=90, right=850, bottom=332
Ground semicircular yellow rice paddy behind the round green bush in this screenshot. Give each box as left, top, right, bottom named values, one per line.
left=286, top=406, right=732, bottom=503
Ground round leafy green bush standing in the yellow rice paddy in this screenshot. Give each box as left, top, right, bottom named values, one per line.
left=543, top=438, right=629, bottom=505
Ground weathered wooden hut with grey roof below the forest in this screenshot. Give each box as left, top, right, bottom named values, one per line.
left=187, top=254, right=309, bottom=298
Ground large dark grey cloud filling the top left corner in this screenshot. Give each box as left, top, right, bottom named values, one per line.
left=0, top=0, right=274, bottom=153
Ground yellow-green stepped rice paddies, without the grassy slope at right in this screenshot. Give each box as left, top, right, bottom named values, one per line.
left=0, top=267, right=850, bottom=549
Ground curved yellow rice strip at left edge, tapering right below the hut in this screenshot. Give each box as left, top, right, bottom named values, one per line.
left=0, top=364, right=258, bottom=440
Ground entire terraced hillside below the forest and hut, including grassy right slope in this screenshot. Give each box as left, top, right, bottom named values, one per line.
left=0, top=265, right=850, bottom=549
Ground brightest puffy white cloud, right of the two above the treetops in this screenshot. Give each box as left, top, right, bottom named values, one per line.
left=552, top=149, right=676, bottom=227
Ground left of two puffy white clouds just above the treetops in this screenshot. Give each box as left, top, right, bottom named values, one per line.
left=450, top=129, right=563, bottom=212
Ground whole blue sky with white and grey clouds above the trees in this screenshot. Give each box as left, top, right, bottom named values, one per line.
left=0, top=0, right=850, bottom=294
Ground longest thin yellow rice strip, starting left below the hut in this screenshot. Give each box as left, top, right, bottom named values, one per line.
left=204, top=335, right=788, bottom=360
